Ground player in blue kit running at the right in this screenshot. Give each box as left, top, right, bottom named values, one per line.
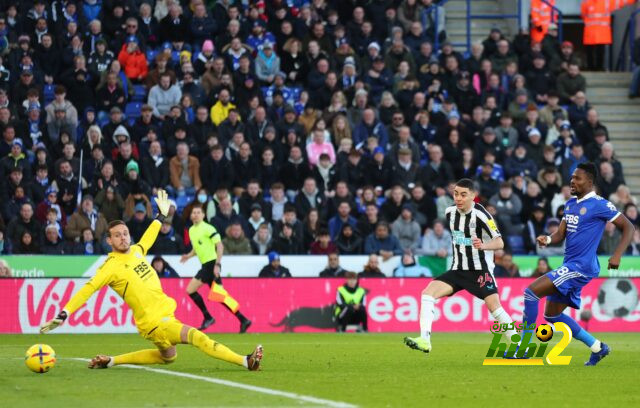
left=523, top=163, right=634, bottom=366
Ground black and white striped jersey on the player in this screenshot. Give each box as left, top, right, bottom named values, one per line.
left=445, top=203, right=500, bottom=273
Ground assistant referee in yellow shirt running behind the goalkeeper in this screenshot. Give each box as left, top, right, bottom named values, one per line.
left=180, top=203, right=251, bottom=333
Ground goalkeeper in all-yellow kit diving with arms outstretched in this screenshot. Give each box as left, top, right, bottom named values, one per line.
left=40, top=190, right=262, bottom=371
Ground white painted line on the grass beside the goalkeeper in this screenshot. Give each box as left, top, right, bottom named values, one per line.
left=72, top=357, right=357, bottom=408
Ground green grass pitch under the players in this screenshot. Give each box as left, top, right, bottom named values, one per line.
left=0, top=333, right=640, bottom=408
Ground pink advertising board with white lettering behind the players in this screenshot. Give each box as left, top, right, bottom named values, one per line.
left=0, top=278, right=640, bottom=333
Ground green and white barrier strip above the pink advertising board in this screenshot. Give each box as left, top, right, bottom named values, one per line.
left=0, top=255, right=640, bottom=278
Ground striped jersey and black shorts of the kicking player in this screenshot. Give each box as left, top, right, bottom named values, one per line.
left=436, top=203, right=500, bottom=299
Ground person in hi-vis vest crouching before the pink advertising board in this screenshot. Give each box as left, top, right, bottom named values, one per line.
left=335, top=272, right=368, bottom=332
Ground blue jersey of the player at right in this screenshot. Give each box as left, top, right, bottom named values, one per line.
left=563, top=192, right=620, bottom=278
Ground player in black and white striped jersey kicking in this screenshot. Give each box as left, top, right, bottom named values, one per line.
left=404, top=179, right=516, bottom=353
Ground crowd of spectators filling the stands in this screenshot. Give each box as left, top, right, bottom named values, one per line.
left=0, top=0, right=640, bottom=262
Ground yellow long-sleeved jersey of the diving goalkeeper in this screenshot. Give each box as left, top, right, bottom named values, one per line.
left=64, top=220, right=176, bottom=335
